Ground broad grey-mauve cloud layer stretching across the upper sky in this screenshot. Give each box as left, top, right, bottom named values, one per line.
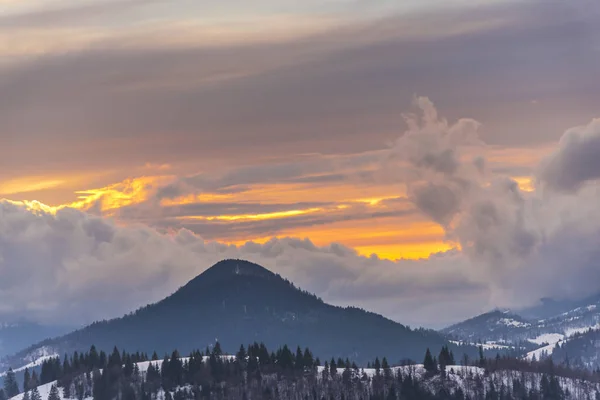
left=0, top=2, right=600, bottom=177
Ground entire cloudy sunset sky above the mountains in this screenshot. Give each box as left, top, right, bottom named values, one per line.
left=0, top=0, right=600, bottom=328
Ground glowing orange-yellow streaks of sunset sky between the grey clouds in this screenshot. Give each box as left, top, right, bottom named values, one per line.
left=0, top=152, right=535, bottom=259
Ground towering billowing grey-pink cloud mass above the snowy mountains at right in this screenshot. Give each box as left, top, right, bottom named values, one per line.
left=392, top=98, right=600, bottom=307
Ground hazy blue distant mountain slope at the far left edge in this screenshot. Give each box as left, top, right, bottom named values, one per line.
left=0, top=322, right=73, bottom=358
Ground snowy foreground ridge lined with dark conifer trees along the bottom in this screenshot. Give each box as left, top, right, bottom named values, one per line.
left=0, top=342, right=600, bottom=400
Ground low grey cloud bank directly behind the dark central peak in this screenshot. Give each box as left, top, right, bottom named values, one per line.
left=0, top=201, right=486, bottom=325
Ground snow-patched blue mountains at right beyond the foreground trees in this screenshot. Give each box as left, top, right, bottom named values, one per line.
left=441, top=296, right=600, bottom=368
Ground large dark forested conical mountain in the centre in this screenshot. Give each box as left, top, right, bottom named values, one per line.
left=3, top=260, right=464, bottom=366
